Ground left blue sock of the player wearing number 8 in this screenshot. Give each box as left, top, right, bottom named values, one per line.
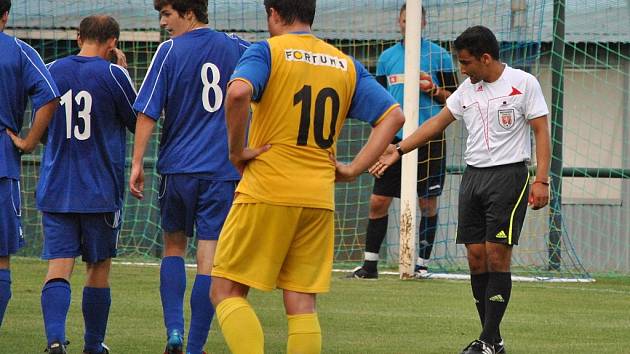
left=160, top=257, right=186, bottom=336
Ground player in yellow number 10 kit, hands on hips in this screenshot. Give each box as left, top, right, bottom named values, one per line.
left=211, top=0, right=404, bottom=353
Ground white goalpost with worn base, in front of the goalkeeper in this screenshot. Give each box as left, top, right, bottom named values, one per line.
left=398, top=0, right=422, bottom=279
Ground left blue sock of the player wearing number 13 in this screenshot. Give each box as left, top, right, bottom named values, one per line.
left=42, top=279, right=71, bottom=344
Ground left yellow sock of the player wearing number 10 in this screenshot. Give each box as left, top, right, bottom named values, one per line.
left=216, top=297, right=265, bottom=354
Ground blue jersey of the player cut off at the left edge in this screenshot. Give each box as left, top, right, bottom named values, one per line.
left=0, top=32, right=59, bottom=179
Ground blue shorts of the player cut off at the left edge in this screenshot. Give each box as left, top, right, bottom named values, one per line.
left=0, top=178, right=24, bottom=257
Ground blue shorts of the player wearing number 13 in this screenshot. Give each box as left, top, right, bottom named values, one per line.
left=42, top=211, right=121, bottom=263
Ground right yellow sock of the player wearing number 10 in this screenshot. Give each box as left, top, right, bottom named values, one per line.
left=287, top=313, right=322, bottom=354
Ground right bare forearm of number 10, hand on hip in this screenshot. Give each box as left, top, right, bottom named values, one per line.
left=335, top=107, right=405, bottom=182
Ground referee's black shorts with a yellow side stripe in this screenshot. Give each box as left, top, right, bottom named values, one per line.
left=457, top=162, right=529, bottom=245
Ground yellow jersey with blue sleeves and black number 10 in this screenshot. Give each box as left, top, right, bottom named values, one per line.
left=232, top=33, right=397, bottom=210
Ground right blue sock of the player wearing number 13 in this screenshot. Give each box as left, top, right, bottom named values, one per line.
left=82, top=286, right=112, bottom=353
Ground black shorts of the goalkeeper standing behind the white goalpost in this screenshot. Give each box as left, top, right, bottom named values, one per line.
left=372, top=133, right=446, bottom=198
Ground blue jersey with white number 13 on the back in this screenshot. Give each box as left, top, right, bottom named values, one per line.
left=37, top=55, right=136, bottom=213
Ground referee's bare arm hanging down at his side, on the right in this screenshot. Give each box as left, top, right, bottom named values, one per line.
left=529, top=116, right=551, bottom=210
